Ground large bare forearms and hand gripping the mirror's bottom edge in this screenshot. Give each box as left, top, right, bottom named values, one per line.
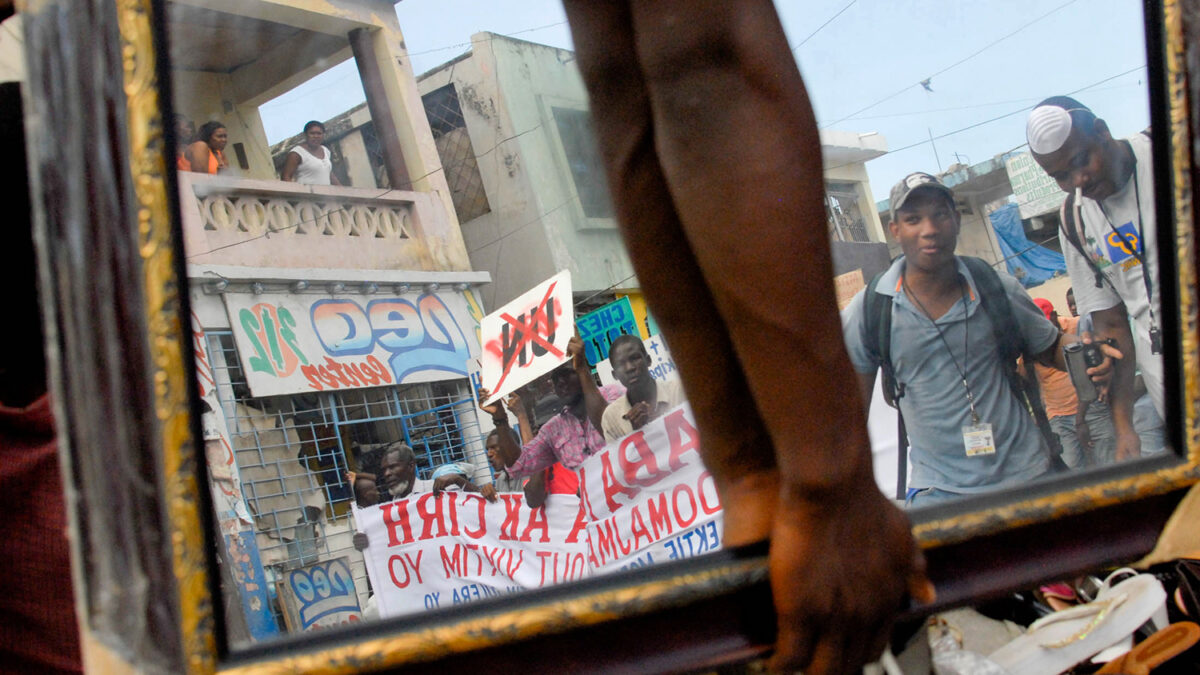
left=564, top=0, right=932, bottom=675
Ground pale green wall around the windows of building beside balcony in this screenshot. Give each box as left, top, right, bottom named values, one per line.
left=419, top=32, right=634, bottom=309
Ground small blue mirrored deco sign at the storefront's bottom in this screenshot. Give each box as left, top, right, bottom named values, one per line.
left=278, top=557, right=362, bottom=632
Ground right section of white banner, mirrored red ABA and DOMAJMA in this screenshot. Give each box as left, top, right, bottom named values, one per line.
left=577, top=404, right=724, bottom=573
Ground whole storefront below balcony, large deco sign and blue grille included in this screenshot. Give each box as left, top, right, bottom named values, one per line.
left=192, top=273, right=486, bottom=639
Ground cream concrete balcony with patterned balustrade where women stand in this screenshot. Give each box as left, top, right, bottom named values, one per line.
left=167, top=0, right=470, bottom=275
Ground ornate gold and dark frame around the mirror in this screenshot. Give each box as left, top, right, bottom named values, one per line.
left=22, top=0, right=1200, bottom=674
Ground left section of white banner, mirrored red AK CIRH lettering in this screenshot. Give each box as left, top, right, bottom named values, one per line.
left=354, top=491, right=589, bottom=619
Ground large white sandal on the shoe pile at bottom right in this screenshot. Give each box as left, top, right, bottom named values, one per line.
left=988, top=574, right=1166, bottom=675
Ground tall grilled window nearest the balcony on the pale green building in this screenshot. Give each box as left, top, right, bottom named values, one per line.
left=421, top=84, right=492, bottom=222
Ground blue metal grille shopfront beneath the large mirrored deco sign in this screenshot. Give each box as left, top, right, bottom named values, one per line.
left=206, top=330, right=486, bottom=631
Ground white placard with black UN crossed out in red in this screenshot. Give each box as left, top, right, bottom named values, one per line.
left=479, top=269, right=575, bottom=404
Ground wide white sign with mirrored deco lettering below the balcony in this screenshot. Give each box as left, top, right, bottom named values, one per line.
left=224, top=285, right=479, bottom=396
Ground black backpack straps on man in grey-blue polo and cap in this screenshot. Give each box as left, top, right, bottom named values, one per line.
left=862, top=256, right=1067, bottom=500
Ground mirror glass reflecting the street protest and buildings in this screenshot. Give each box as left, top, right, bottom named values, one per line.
left=167, top=0, right=1165, bottom=647
